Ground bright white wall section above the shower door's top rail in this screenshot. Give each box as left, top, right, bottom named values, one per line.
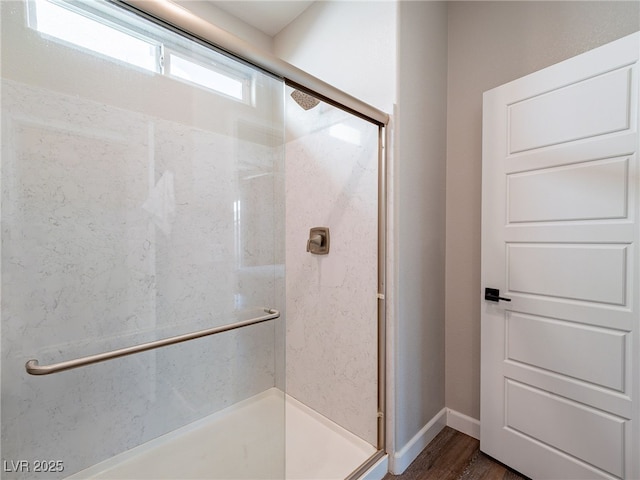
left=273, top=0, right=396, bottom=112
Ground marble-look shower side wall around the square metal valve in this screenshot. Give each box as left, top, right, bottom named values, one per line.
left=286, top=101, right=378, bottom=445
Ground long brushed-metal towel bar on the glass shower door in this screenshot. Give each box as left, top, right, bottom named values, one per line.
left=25, top=308, right=280, bottom=375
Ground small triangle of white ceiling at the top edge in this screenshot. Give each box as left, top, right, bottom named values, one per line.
left=209, top=0, right=313, bottom=37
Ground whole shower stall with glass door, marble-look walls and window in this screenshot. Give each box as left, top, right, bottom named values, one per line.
left=0, top=0, right=384, bottom=479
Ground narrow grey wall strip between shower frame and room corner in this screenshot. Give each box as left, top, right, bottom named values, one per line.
left=394, top=2, right=447, bottom=458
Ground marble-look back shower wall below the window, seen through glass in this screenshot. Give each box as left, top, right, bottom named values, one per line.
left=1, top=80, right=283, bottom=479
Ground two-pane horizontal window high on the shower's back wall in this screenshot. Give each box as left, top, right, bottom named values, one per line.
left=28, top=0, right=252, bottom=103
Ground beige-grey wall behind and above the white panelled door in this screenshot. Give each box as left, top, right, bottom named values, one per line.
left=446, top=1, right=640, bottom=419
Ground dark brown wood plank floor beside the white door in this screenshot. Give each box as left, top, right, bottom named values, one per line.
left=383, top=427, right=527, bottom=480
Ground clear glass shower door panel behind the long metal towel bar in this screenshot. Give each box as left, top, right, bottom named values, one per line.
left=0, top=0, right=285, bottom=479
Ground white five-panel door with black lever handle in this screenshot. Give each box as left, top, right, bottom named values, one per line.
left=480, top=34, right=640, bottom=480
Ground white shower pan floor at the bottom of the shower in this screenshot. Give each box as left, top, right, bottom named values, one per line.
left=67, top=388, right=375, bottom=480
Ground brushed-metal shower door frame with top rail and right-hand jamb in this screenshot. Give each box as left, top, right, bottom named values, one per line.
left=107, top=0, right=389, bottom=474
